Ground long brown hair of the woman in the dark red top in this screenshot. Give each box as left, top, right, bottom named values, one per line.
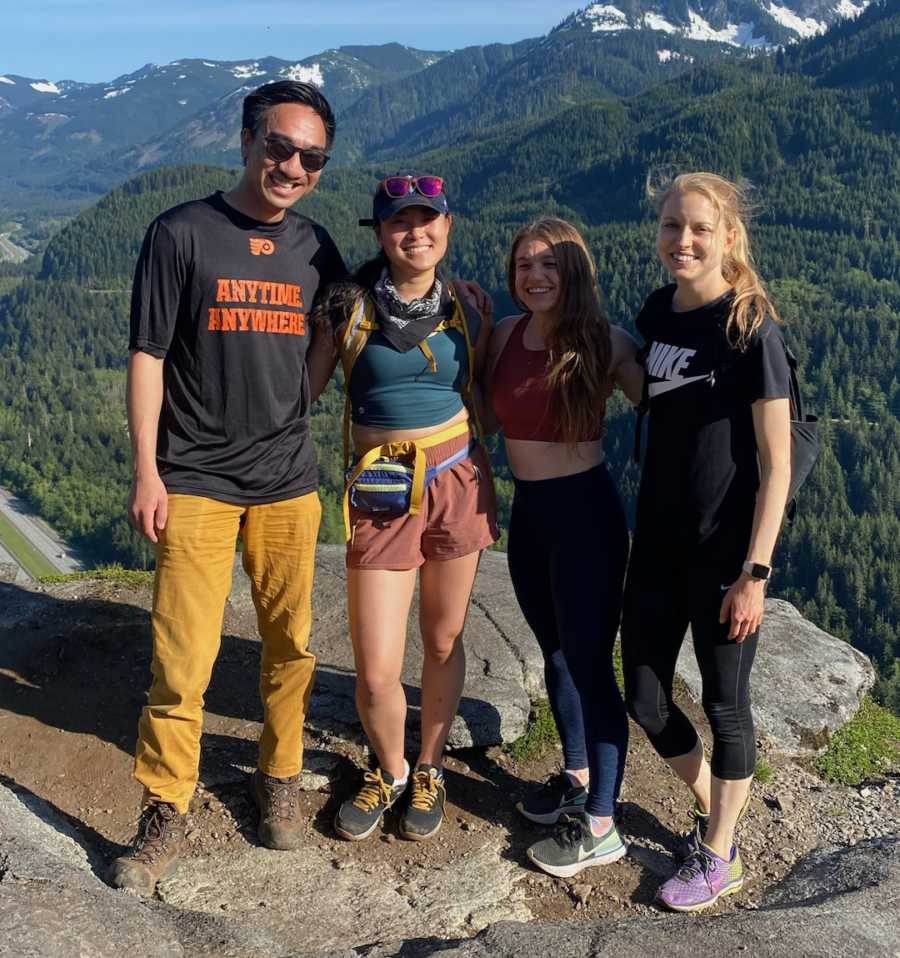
left=506, top=217, right=612, bottom=444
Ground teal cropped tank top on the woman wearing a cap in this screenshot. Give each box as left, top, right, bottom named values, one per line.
left=349, top=329, right=469, bottom=429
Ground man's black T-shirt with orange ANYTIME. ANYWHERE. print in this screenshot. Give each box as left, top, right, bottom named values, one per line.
left=129, top=193, right=346, bottom=504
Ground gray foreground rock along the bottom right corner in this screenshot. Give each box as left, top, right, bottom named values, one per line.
left=340, top=838, right=900, bottom=958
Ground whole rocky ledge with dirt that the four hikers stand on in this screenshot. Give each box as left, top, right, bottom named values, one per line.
left=0, top=547, right=884, bottom=958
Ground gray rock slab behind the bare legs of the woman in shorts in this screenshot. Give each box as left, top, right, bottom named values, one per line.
left=225, top=546, right=543, bottom=748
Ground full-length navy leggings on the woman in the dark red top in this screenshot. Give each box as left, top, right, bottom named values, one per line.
left=507, top=465, right=628, bottom=815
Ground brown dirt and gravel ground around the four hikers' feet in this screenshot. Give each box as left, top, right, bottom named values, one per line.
left=0, top=586, right=900, bottom=919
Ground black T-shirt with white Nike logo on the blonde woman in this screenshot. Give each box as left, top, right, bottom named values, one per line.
left=636, top=285, right=790, bottom=561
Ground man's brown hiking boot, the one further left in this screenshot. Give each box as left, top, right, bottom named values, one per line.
left=106, top=802, right=187, bottom=896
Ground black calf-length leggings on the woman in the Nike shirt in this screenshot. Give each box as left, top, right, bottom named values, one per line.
left=622, top=540, right=759, bottom=779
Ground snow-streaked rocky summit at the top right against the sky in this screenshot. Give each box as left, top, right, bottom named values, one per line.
left=555, top=0, right=870, bottom=49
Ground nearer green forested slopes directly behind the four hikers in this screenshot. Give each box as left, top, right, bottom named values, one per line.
left=0, top=6, right=900, bottom=711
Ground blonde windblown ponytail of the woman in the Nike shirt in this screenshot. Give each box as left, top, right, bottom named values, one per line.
left=647, top=172, right=781, bottom=350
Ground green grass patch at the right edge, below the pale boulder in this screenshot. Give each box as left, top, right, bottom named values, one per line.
left=814, top=698, right=900, bottom=785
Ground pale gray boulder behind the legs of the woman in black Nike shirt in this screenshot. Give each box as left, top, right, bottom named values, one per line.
left=678, top=599, right=875, bottom=755
